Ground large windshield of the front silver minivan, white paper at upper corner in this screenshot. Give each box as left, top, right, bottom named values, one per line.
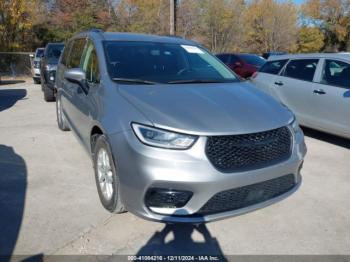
left=104, top=41, right=238, bottom=83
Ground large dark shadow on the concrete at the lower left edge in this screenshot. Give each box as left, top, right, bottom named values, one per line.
left=0, top=145, right=27, bottom=260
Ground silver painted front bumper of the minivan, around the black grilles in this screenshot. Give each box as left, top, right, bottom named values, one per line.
left=109, top=127, right=306, bottom=223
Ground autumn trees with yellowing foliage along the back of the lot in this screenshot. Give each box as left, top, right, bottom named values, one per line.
left=0, top=0, right=344, bottom=53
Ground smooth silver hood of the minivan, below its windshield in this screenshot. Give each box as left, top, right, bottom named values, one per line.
left=119, top=82, right=293, bottom=135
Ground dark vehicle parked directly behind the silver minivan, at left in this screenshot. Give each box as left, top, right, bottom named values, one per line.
left=41, top=43, right=64, bottom=102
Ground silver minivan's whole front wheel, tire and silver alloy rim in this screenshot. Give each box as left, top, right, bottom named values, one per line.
left=93, top=135, right=125, bottom=213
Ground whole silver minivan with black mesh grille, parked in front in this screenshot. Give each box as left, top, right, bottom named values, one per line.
left=56, top=30, right=306, bottom=223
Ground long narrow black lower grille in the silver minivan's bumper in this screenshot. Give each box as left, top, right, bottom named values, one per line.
left=196, top=174, right=295, bottom=215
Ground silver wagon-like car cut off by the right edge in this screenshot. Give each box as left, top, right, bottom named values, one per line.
left=252, top=53, right=350, bottom=138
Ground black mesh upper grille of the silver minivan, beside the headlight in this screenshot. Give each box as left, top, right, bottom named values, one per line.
left=205, top=127, right=292, bottom=173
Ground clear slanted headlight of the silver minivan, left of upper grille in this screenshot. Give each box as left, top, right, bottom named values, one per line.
left=131, top=123, right=197, bottom=149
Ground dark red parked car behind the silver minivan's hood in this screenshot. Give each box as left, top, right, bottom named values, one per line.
left=216, top=54, right=266, bottom=78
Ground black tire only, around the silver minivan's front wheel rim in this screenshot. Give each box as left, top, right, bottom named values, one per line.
left=93, top=135, right=122, bottom=213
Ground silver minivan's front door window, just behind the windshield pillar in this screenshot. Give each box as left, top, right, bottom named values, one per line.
left=83, top=42, right=100, bottom=83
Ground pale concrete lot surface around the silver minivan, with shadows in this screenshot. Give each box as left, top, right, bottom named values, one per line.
left=0, top=80, right=350, bottom=255
